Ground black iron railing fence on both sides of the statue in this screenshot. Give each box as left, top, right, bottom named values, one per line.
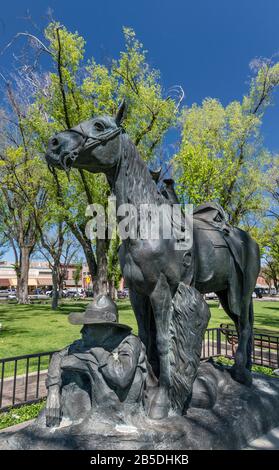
left=0, top=327, right=279, bottom=410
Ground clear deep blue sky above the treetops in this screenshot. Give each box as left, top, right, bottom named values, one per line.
left=0, top=0, right=279, bottom=151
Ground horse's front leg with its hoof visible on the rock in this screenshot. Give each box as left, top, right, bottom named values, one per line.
left=148, top=273, right=172, bottom=419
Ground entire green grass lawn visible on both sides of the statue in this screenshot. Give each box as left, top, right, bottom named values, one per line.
left=0, top=300, right=279, bottom=358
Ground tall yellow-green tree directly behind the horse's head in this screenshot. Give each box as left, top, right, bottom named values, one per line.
left=17, top=22, right=179, bottom=294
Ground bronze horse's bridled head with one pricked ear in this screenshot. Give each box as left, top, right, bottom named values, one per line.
left=46, top=100, right=125, bottom=173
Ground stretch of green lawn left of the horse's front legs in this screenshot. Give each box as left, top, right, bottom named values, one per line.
left=0, top=300, right=137, bottom=358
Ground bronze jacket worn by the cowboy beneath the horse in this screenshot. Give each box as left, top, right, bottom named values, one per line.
left=46, top=334, right=156, bottom=406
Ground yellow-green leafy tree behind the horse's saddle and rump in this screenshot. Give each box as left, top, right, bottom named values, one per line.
left=173, top=60, right=279, bottom=225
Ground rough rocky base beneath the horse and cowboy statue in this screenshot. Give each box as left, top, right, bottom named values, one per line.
left=0, top=362, right=279, bottom=450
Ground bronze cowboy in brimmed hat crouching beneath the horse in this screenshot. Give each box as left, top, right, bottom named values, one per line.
left=46, top=295, right=157, bottom=427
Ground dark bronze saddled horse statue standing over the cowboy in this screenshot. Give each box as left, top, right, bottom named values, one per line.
left=46, top=101, right=260, bottom=419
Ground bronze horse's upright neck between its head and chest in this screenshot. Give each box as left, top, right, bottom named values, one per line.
left=110, top=135, right=162, bottom=207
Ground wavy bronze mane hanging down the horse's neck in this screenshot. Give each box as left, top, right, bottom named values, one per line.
left=122, top=134, right=168, bottom=205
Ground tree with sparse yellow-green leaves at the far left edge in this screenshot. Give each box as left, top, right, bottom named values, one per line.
left=0, top=77, right=46, bottom=303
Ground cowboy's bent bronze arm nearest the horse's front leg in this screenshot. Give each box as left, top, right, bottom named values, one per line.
left=100, top=335, right=141, bottom=389
